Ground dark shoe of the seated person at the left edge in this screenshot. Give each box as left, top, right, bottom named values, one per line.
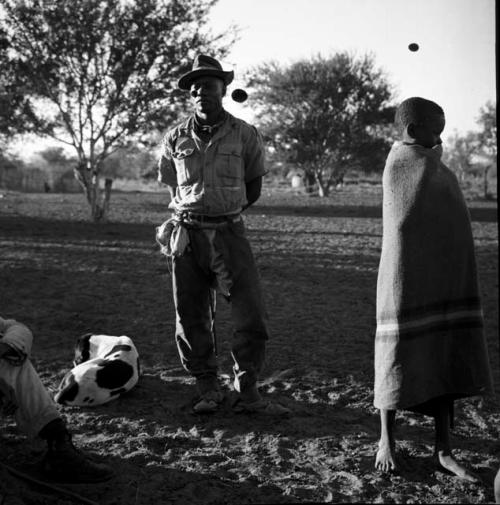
left=42, top=439, right=114, bottom=484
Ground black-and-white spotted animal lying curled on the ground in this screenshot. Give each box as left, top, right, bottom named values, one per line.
left=55, top=333, right=140, bottom=406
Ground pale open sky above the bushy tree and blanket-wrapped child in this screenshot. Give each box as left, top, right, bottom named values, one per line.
left=210, top=0, right=496, bottom=140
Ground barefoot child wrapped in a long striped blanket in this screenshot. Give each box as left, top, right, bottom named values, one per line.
left=374, top=97, right=492, bottom=481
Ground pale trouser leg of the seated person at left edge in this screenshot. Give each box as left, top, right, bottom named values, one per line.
left=0, top=359, right=61, bottom=438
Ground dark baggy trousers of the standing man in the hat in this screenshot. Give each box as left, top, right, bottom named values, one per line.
left=172, top=220, right=269, bottom=392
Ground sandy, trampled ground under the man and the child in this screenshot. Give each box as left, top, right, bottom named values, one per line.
left=0, top=185, right=500, bottom=505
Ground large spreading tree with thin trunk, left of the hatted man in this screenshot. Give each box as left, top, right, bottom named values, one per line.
left=0, top=0, right=235, bottom=221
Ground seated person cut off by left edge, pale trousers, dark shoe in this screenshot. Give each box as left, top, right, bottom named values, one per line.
left=0, top=317, right=114, bottom=483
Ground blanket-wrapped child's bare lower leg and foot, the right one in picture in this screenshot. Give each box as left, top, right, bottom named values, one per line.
left=434, top=401, right=479, bottom=482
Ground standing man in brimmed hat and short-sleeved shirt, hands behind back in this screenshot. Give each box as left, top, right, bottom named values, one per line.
left=157, top=55, right=289, bottom=415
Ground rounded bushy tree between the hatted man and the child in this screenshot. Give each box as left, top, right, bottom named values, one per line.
left=247, top=52, right=394, bottom=196
